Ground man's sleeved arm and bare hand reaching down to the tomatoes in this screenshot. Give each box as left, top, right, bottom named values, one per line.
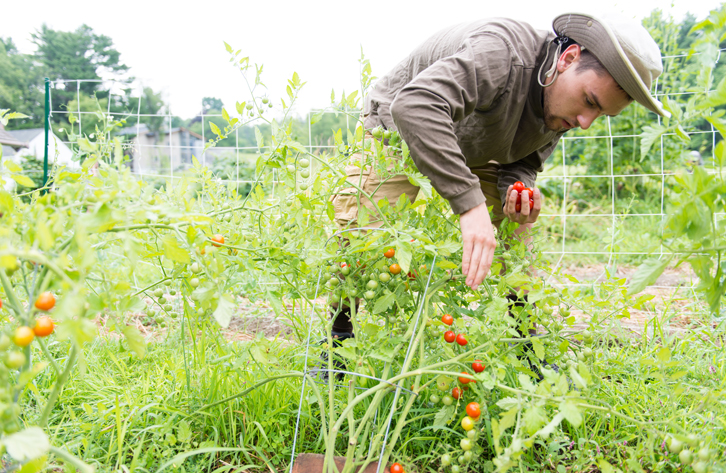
left=391, top=35, right=512, bottom=289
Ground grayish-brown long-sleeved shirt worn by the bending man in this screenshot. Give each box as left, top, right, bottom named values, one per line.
left=363, top=18, right=562, bottom=214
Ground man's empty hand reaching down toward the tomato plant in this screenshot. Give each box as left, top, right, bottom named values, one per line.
left=459, top=202, right=497, bottom=290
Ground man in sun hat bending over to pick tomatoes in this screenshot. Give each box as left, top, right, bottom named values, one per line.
left=333, top=13, right=666, bottom=368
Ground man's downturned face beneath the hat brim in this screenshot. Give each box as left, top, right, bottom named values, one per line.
left=544, top=45, right=631, bottom=132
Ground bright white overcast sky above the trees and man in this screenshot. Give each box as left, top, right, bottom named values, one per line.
left=5, top=0, right=720, bottom=118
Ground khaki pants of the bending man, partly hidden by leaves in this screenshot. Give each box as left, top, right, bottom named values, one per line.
left=332, top=135, right=504, bottom=229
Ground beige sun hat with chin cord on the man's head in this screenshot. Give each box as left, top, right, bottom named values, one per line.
left=552, top=13, right=670, bottom=116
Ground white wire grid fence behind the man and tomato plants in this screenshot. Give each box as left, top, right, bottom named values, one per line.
left=1, top=48, right=723, bottom=298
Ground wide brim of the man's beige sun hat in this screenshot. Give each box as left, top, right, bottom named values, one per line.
left=552, top=13, right=670, bottom=117
